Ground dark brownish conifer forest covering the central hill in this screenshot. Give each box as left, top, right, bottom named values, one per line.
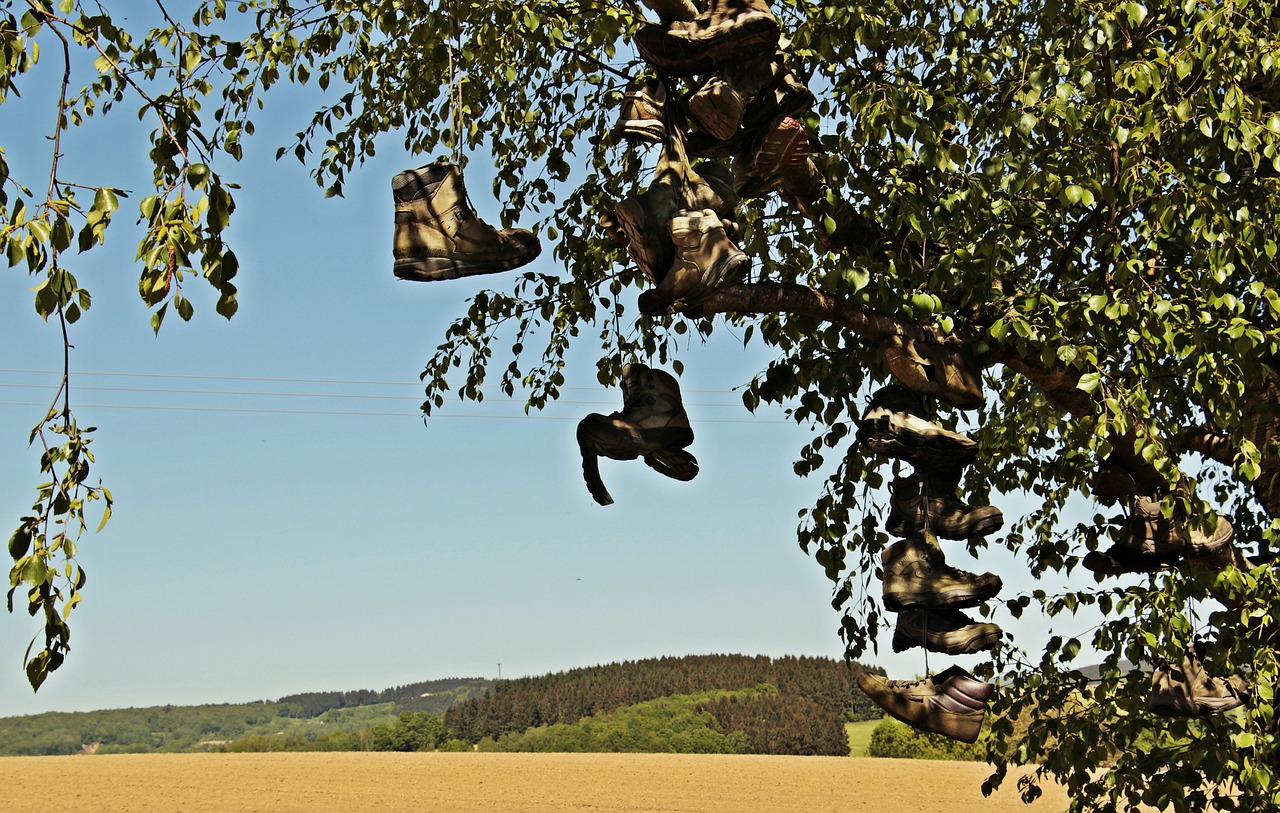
left=444, top=654, right=881, bottom=753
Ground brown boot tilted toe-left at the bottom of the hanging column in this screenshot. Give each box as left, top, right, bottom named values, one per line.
left=858, top=666, right=996, bottom=743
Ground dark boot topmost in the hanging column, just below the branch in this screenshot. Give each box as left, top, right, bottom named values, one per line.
left=858, top=384, right=978, bottom=469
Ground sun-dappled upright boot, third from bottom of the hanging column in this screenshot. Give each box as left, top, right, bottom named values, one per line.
left=881, top=531, right=1004, bottom=612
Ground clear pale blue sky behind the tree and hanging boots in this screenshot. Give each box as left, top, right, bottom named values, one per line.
left=0, top=1, right=1105, bottom=716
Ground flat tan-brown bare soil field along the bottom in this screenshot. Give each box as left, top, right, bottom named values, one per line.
left=0, top=753, right=1068, bottom=813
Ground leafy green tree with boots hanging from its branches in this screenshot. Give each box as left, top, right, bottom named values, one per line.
left=0, top=0, right=1280, bottom=810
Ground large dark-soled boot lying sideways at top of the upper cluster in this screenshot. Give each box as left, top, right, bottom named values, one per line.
left=636, top=0, right=782, bottom=77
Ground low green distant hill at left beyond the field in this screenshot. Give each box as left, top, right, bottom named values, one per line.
left=0, top=677, right=493, bottom=757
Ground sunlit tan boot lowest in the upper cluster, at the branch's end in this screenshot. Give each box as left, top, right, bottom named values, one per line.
left=636, top=209, right=751, bottom=315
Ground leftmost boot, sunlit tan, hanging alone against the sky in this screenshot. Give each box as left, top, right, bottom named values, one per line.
left=392, top=161, right=541, bottom=282
